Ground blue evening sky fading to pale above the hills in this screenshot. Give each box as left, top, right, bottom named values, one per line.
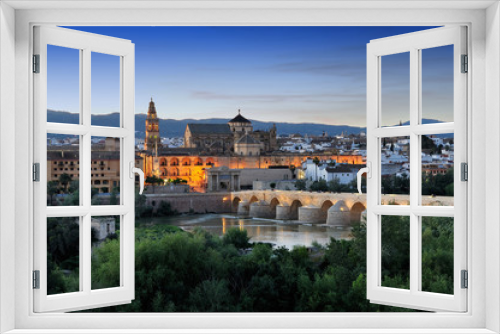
left=47, top=27, right=453, bottom=126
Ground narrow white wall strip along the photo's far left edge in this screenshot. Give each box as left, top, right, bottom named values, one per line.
left=0, top=3, right=16, bottom=333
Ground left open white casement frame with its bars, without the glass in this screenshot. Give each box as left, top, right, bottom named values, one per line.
left=33, top=26, right=135, bottom=312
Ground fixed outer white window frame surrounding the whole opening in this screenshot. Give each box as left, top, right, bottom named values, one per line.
left=0, top=0, right=500, bottom=333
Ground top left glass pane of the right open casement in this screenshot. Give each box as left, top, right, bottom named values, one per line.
left=381, top=52, right=410, bottom=126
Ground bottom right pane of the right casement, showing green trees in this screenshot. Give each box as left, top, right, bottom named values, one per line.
left=422, top=217, right=454, bottom=294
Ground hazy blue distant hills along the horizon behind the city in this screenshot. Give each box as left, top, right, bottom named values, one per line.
left=47, top=109, right=446, bottom=137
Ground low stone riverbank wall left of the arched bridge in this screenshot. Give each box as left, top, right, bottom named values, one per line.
left=146, top=193, right=231, bottom=213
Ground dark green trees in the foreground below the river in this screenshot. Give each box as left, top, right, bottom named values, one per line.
left=61, top=216, right=453, bottom=312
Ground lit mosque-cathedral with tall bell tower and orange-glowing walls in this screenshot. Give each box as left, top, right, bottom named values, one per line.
left=139, top=99, right=364, bottom=191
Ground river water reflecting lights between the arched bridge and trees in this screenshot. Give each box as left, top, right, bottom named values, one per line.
left=146, top=214, right=352, bottom=249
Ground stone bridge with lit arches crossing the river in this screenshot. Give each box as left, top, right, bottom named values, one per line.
left=231, top=190, right=453, bottom=226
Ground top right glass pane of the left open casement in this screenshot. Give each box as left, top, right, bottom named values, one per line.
left=91, top=52, right=120, bottom=127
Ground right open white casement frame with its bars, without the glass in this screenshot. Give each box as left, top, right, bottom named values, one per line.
left=366, top=25, right=470, bottom=312
